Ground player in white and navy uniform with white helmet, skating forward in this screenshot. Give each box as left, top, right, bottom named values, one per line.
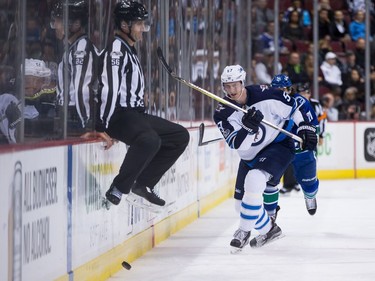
left=214, top=65, right=317, bottom=252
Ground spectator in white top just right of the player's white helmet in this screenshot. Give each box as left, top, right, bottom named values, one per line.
left=255, top=49, right=282, bottom=84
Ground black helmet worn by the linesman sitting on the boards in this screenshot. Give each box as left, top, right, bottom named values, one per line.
left=113, top=0, right=148, bottom=28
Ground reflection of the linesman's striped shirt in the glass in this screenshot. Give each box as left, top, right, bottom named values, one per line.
left=57, top=35, right=98, bottom=128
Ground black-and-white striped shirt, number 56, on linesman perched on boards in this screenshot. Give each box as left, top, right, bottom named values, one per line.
left=96, top=36, right=145, bottom=132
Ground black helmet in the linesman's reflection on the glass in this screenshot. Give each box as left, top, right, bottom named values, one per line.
left=51, top=0, right=89, bottom=26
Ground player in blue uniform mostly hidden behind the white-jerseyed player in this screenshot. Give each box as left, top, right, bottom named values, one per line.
left=271, top=79, right=320, bottom=216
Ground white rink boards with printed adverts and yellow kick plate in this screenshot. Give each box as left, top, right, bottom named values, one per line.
left=0, top=122, right=375, bottom=281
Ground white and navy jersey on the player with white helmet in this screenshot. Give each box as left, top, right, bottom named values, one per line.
left=214, top=85, right=306, bottom=160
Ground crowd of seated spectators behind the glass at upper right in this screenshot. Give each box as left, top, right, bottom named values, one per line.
left=252, top=0, right=375, bottom=121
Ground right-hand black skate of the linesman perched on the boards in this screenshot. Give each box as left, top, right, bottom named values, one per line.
left=126, top=185, right=165, bottom=213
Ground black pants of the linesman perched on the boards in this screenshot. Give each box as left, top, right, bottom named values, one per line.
left=106, top=108, right=189, bottom=194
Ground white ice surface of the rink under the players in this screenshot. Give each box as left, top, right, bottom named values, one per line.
left=108, top=179, right=375, bottom=281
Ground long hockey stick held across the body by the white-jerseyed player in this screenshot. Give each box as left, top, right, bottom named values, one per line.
left=157, top=47, right=303, bottom=143
